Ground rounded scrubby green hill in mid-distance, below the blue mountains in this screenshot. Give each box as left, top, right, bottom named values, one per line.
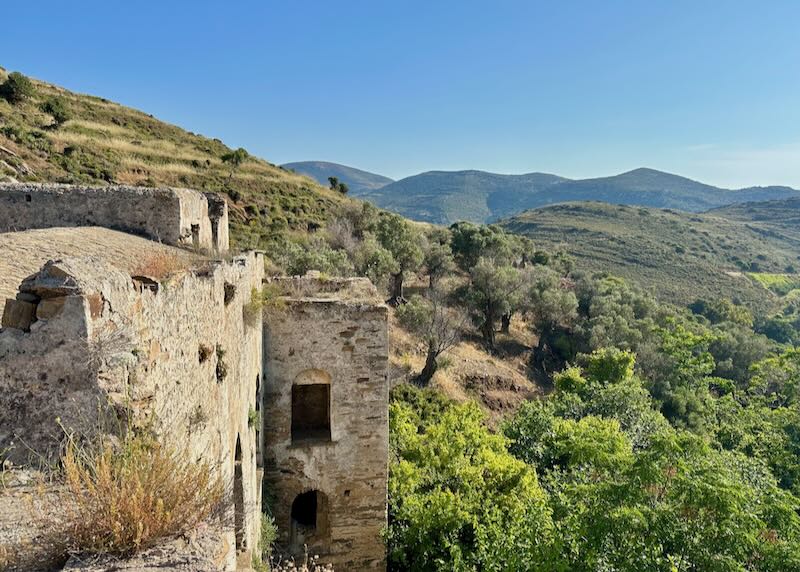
left=501, top=202, right=800, bottom=308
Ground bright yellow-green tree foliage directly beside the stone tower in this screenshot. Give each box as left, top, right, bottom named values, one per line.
left=388, top=388, right=551, bottom=572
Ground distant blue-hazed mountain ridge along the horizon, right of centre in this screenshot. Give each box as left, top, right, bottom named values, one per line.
left=363, top=165, right=798, bottom=224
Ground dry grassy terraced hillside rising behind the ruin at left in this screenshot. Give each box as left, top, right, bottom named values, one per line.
left=0, top=68, right=345, bottom=247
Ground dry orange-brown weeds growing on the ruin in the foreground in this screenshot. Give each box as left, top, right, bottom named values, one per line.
left=58, top=436, right=223, bottom=556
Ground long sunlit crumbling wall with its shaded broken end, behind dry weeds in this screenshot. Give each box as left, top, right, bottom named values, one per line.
left=0, top=253, right=263, bottom=570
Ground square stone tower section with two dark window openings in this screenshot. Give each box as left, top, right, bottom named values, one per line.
left=264, top=279, right=388, bottom=571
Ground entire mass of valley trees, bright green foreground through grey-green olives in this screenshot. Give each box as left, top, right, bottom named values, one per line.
left=388, top=223, right=800, bottom=572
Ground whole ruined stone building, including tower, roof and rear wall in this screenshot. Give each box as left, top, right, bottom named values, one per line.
left=0, top=184, right=388, bottom=571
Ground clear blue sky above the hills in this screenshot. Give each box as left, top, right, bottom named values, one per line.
left=0, top=0, right=800, bottom=187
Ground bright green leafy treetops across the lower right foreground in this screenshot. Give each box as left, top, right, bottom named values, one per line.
left=389, top=340, right=800, bottom=572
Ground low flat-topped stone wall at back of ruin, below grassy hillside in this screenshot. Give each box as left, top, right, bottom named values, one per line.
left=0, top=183, right=228, bottom=252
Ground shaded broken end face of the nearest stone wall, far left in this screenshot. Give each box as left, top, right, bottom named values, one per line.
left=0, top=261, right=114, bottom=466
